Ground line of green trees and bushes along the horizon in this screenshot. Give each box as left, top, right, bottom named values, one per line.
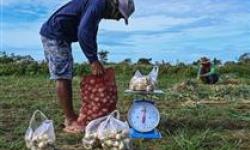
left=0, top=51, right=250, bottom=77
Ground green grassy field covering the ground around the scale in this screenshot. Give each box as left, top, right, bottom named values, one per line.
left=0, top=69, right=250, bottom=150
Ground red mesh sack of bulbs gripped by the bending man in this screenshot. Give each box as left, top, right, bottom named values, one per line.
left=78, top=68, right=117, bottom=127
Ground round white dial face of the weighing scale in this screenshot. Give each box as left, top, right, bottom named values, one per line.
left=128, top=101, right=160, bottom=132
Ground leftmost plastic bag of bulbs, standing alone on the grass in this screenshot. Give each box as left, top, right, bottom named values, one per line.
left=25, top=110, right=56, bottom=150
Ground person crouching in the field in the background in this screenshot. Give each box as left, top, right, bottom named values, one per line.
left=197, top=57, right=219, bottom=84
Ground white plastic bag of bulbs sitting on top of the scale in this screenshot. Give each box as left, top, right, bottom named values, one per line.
left=129, top=66, right=159, bottom=91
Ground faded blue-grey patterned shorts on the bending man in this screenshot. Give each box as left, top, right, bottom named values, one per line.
left=41, top=36, right=73, bottom=80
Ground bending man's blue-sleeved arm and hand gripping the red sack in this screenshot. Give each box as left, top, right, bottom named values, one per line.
left=78, top=1, right=105, bottom=75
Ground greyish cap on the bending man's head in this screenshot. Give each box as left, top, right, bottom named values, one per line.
left=119, top=0, right=135, bottom=24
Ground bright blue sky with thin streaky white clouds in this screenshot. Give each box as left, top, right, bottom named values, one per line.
left=0, top=0, right=250, bottom=63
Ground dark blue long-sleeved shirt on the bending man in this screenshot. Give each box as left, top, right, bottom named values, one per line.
left=40, top=0, right=106, bottom=62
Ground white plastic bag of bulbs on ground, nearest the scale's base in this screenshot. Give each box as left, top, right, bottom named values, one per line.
left=97, top=110, right=131, bottom=150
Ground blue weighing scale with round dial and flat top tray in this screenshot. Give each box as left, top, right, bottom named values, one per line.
left=125, top=90, right=164, bottom=139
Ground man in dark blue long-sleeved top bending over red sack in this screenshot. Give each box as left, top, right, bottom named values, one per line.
left=40, top=0, right=135, bottom=133
